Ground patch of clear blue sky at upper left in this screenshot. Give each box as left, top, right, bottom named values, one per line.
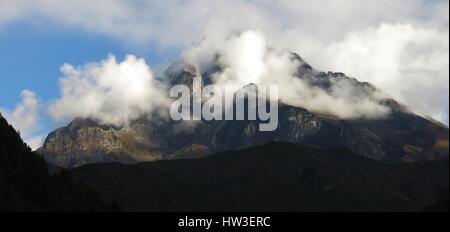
left=0, top=23, right=177, bottom=108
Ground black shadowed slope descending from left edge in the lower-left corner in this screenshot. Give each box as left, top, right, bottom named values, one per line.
left=0, top=115, right=120, bottom=212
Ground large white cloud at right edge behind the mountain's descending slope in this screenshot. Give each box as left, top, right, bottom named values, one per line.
left=300, top=23, right=449, bottom=124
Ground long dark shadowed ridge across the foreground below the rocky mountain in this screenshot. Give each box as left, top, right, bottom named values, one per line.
left=71, top=142, right=449, bottom=211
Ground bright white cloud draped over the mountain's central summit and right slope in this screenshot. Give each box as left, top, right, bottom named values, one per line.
left=185, top=31, right=390, bottom=119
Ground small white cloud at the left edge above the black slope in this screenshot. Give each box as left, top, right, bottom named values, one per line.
left=1, top=90, right=44, bottom=149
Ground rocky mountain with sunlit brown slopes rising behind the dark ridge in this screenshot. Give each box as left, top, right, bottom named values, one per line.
left=38, top=54, right=449, bottom=167
